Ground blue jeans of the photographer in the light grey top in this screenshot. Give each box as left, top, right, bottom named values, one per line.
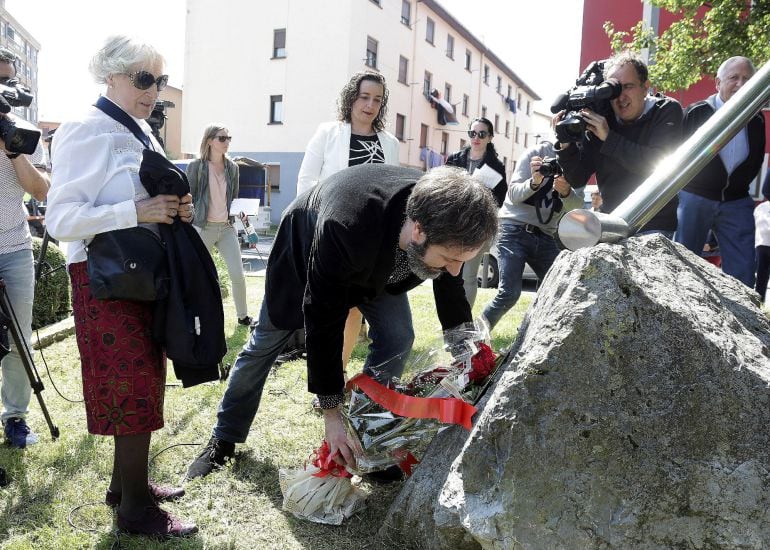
left=482, top=223, right=559, bottom=330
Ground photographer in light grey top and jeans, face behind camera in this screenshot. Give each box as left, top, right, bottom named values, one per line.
left=482, top=141, right=583, bottom=330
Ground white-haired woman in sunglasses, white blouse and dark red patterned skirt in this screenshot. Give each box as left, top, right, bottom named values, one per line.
left=46, top=36, right=197, bottom=536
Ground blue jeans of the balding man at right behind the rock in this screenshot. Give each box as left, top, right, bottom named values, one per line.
left=674, top=191, right=755, bottom=288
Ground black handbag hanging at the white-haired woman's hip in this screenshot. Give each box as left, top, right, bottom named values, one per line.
left=86, top=227, right=169, bottom=302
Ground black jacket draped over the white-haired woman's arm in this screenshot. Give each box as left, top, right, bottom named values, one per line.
left=139, top=149, right=227, bottom=387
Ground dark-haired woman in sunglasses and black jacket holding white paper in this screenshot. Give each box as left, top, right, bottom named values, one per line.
left=446, top=117, right=508, bottom=307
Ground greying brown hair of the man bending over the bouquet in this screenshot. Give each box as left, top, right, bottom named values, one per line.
left=406, top=166, right=498, bottom=248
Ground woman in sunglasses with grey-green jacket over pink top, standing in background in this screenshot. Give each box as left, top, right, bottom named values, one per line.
left=187, top=124, right=251, bottom=326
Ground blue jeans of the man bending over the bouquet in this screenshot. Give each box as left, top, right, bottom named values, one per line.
left=213, top=293, right=414, bottom=443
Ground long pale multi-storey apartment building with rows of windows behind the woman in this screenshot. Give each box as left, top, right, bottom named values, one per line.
left=182, top=0, right=540, bottom=222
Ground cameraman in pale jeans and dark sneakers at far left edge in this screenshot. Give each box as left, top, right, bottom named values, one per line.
left=0, top=48, right=50, bottom=449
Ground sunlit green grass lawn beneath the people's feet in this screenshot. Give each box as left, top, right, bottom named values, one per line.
left=0, top=277, right=531, bottom=550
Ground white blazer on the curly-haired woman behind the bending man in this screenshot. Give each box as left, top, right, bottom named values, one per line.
left=297, top=121, right=399, bottom=195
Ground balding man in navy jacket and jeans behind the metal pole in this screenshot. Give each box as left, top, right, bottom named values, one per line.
left=674, top=56, right=765, bottom=288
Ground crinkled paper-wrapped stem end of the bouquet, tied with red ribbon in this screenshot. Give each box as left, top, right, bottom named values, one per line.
left=278, top=441, right=366, bottom=525
